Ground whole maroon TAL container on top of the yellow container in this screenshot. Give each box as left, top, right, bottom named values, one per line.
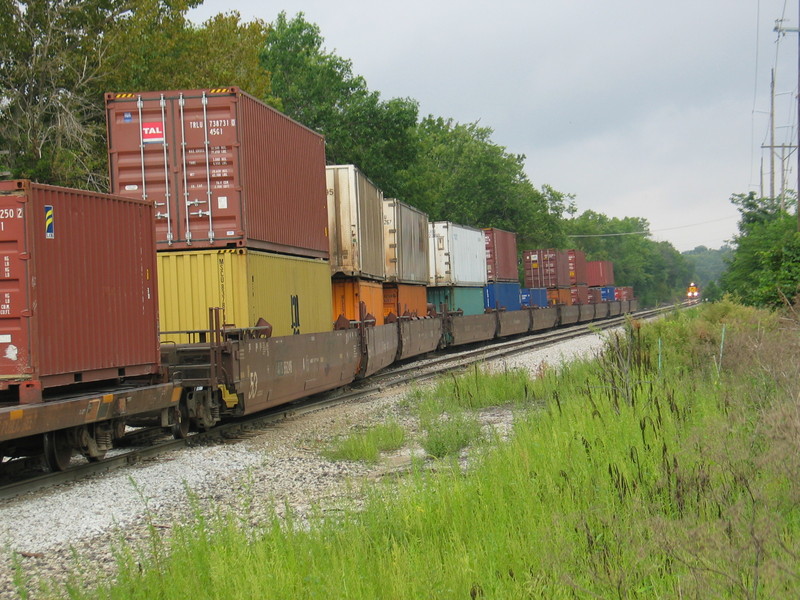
left=106, top=87, right=328, bottom=258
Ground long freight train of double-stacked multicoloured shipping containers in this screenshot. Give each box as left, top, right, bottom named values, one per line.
left=0, top=88, right=637, bottom=470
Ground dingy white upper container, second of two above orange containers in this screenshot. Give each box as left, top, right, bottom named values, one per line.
left=383, top=198, right=428, bottom=285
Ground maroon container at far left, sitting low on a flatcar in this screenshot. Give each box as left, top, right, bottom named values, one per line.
left=0, top=180, right=160, bottom=402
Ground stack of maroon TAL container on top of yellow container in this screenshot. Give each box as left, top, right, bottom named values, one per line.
left=106, top=87, right=333, bottom=342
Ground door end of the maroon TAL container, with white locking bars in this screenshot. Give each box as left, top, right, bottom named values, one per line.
left=107, top=90, right=244, bottom=248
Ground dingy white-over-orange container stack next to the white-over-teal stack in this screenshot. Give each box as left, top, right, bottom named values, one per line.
left=383, top=198, right=429, bottom=318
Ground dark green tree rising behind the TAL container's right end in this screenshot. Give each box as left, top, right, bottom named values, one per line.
left=260, top=12, right=418, bottom=196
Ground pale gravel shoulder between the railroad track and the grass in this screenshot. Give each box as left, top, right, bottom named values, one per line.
left=0, top=334, right=605, bottom=600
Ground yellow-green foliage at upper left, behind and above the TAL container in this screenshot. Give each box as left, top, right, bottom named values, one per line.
left=0, top=0, right=269, bottom=191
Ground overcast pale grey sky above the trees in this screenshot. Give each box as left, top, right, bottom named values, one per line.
left=190, top=0, right=798, bottom=251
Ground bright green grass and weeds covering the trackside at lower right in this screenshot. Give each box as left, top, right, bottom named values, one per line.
left=28, top=303, right=800, bottom=599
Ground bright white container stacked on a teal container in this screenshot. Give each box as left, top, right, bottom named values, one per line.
left=428, top=221, right=487, bottom=315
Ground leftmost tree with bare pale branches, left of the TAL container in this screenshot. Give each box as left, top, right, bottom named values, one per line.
left=0, top=0, right=125, bottom=189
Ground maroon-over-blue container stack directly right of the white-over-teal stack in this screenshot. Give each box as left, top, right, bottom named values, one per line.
left=483, top=228, right=522, bottom=310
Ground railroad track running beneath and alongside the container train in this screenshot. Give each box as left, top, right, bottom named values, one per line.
left=0, top=307, right=675, bottom=501
